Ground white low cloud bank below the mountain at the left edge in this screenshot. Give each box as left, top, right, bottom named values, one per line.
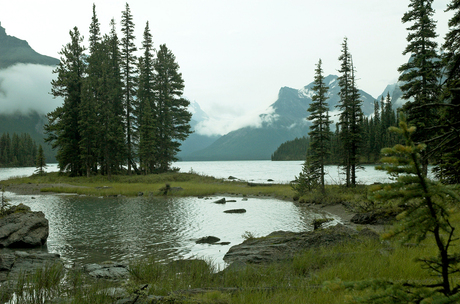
left=0, top=64, right=62, bottom=114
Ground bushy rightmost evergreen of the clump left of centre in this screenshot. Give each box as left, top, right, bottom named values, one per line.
left=154, top=44, right=192, bottom=172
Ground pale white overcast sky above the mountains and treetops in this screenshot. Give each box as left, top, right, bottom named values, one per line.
left=0, top=0, right=450, bottom=132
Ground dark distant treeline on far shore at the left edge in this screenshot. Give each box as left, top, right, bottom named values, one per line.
left=0, top=133, right=38, bottom=167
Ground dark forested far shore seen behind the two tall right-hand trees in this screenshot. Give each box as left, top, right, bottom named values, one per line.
left=271, top=95, right=401, bottom=165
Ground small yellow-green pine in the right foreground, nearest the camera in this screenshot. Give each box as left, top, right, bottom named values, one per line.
left=356, top=117, right=460, bottom=303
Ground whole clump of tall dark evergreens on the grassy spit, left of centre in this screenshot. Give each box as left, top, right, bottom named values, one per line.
left=45, top=4, right=191, bottom=176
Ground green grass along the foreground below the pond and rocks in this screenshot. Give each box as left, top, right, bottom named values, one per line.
left=4, top=236, right=450, bottom=304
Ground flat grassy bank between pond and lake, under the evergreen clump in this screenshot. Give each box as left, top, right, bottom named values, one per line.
left=0, top=173, right=294, bottom=199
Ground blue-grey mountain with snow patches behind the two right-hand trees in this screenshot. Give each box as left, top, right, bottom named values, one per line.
left=182, top=75, right=374, bottom=160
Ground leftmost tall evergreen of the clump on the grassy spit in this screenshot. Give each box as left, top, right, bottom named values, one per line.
left=44, top=27, right=86, bottom=176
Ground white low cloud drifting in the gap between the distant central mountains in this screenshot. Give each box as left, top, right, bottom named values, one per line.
left=195, top=107, right=277, bottom=136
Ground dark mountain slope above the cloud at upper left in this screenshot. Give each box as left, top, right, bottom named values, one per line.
left=0, top=23, right=59, bottom=69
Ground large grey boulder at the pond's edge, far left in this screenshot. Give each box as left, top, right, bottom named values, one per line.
left=0, top=205, right=49, bottom=248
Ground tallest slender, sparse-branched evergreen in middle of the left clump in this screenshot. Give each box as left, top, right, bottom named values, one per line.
left=120, top=3, right=137, bottom=174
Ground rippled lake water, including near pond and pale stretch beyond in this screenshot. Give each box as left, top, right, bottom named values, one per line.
left=0, top=161, right=387, bottom=268
